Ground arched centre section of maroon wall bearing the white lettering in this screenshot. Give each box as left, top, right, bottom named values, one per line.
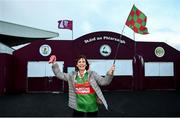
left=73, top=32, right=134, bottom=59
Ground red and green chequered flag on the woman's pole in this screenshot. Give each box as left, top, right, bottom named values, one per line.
left=126, top=5, right=148, bottom=34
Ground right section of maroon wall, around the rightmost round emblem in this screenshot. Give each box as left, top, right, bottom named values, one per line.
left=136, top=42, right=180, bottom=89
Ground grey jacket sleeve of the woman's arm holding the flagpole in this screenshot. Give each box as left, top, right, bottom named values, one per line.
left=92, top=71, right=113, bottom=86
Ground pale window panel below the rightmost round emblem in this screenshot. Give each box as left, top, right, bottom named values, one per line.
left=145, top=62, right=174, bottom=76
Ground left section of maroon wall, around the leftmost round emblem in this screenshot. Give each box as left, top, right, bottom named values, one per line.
left=14, top=40, right=73, bottom=91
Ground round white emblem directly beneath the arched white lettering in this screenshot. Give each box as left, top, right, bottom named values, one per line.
left=99, top=44, right=111, bottom=57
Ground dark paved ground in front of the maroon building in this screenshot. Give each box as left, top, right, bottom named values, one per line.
left=0, top=91, right=180, bottom=117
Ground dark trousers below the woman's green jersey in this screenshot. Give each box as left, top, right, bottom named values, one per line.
left=73, top=110, right=98, bottom=117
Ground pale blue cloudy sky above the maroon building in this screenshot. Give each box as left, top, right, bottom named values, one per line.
left=0, top=0, right=180, bottom=51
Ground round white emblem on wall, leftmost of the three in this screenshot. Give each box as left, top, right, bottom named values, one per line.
left=39, top=44, right=51, bottom=56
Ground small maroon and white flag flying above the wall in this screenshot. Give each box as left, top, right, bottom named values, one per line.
left=58, top=20, right=73, bottom=30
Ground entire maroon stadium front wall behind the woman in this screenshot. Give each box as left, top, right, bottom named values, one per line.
left=14, top=32, right=180, bottom=91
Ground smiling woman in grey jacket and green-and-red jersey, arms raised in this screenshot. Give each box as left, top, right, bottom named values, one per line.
left=49, top=55, right=115, bottom=117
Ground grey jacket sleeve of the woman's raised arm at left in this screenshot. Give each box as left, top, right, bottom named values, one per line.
left=52, top=63, right=70, bottom=81
